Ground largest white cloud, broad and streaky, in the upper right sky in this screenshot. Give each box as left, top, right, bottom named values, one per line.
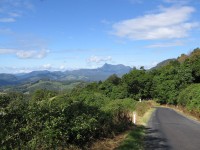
left=113, top=6, right=199, bottom=40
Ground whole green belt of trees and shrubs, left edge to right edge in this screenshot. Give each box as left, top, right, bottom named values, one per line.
left=0, top=48, right=200, bottom=149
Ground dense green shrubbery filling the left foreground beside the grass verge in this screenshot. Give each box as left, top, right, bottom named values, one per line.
left=0, top=88, right=136, bottom=149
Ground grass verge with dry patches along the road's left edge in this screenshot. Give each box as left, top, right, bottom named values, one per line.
left=89, top=101, right=158, bottom=150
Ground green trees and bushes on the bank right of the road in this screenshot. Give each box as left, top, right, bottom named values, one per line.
left=152, top=48, right=200, bottom=111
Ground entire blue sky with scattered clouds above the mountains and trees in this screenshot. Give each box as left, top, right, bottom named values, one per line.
left=0, top=0, right=200, bottom=73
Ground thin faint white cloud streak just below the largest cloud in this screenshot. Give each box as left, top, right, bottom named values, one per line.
left=146, top=41, right=184, bottom=48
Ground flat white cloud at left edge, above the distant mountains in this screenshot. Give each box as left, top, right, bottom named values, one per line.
left=0, top=48, right=49, bottom=59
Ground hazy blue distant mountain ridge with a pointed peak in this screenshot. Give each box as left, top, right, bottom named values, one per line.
left=0, top=63, right=132, bottom=86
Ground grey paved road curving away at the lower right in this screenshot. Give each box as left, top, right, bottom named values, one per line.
left=145, top=107, right=200, bottom=150
